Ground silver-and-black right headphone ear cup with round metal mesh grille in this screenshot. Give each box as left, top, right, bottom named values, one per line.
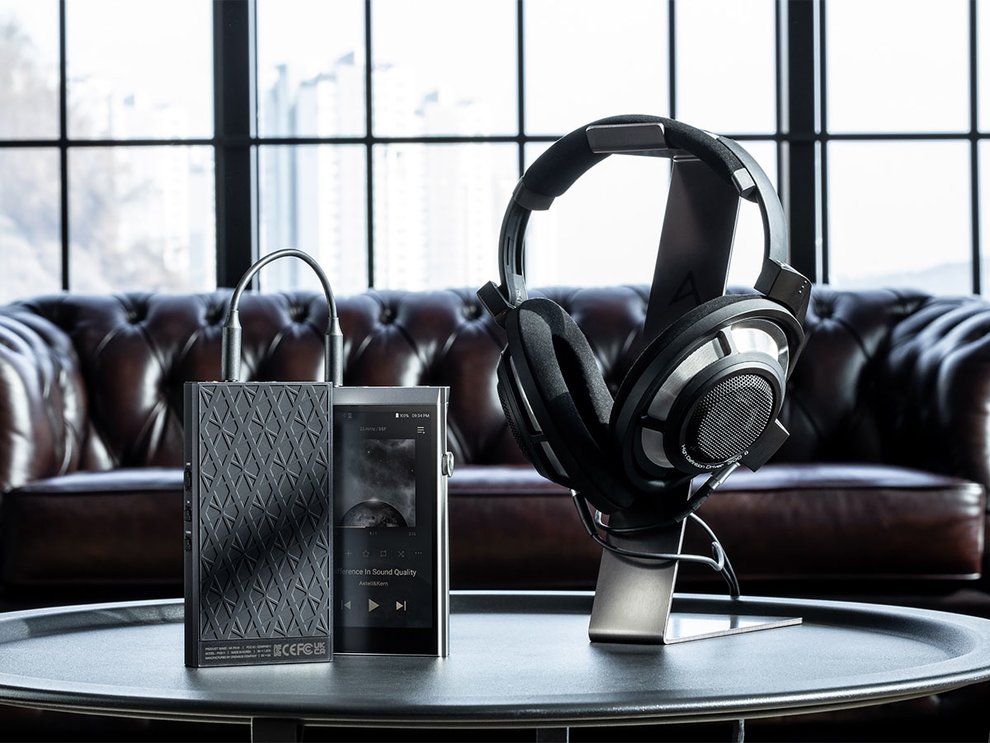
left=610, top=295, right=804, bottom=486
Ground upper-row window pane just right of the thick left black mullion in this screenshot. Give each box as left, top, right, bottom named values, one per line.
left=257, top=0, right=365, bottom=137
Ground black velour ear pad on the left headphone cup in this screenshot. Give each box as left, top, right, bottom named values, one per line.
left=508, top=298, right=635, bottom=512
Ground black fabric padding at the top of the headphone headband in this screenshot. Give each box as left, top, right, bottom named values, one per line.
left=523, top=114, right=745, bottom=198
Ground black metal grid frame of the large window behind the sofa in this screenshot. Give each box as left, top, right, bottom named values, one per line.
left=0, top=0, right=990, bottom=294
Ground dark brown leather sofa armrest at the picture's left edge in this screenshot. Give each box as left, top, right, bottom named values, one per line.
left=0, top=304, right=87, bottom=493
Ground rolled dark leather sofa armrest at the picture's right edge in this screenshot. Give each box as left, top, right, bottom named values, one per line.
left=878, top=297, right=990, bottom=490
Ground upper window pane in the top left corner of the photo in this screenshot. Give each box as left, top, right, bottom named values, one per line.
left=0, top=0, right=59, bottom=139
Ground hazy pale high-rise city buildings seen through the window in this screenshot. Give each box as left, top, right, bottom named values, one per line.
left=259, top=52, right=517, bottom=292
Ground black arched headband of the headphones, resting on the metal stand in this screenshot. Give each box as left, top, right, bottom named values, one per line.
left=478, top=115, right=809, bottom=326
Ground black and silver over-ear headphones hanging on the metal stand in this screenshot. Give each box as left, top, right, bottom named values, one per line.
left=478, top=115, right=810, bottom=523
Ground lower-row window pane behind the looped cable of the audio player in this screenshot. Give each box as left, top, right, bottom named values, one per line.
left=258, top=145, right=368, bottom=294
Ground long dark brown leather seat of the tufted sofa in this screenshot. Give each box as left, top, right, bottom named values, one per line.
left=0, top=464, right=986, bottom=595
